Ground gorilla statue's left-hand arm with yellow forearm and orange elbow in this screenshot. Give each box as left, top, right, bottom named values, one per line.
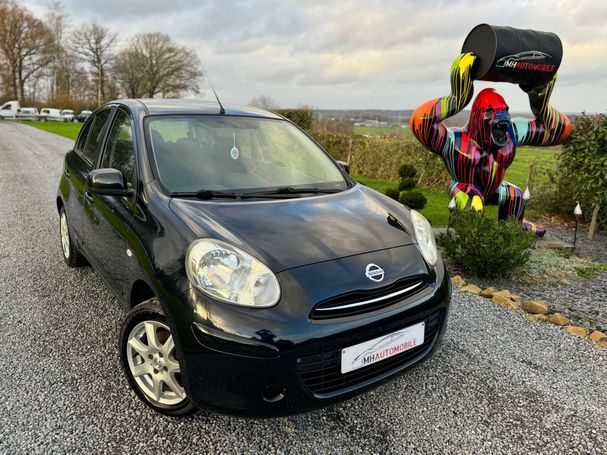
left=410, top=53, right=476, bottom=155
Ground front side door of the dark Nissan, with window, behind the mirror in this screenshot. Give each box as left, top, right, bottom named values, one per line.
left=83, top=108, right=137, bottom=295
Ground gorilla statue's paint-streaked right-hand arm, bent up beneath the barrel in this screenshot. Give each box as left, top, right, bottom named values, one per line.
left=513, top=74, right=571, bottom=147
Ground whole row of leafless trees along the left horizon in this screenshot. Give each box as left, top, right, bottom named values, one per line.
left=0, top=0, right=203, bottom=109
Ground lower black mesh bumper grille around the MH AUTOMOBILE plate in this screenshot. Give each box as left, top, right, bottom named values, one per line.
left=297, top=310, right=444, bottom=398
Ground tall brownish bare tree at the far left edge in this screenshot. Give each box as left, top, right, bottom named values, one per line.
left=0, top=1, right=51, bottom=101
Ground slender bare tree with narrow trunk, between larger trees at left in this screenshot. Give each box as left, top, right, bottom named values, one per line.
left=72, top=22, right=117, bottom=105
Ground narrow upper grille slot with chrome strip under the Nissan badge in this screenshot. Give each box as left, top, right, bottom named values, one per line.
left=310, top=278, right=428, bottom=319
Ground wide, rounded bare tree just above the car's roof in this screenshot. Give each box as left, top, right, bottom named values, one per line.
left=114, top=32, right=202, bottom=98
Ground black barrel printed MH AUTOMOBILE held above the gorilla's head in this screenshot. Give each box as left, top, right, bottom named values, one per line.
left=462, top=24, right=563, bottom=87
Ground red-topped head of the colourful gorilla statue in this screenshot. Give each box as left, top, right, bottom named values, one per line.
left=467, top=89, right=513, bottom=152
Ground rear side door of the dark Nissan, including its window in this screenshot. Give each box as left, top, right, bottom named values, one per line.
left=63, top=109, right=112, bottom=249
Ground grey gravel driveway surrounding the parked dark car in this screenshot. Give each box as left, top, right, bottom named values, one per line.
left=0, top=121, right=607, bottom=454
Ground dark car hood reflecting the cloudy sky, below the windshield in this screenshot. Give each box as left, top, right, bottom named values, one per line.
left=170, top=185, right=415, bottom=272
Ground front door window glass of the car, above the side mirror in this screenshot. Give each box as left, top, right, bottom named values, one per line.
left=101, top=110, right=135, bottom=187
